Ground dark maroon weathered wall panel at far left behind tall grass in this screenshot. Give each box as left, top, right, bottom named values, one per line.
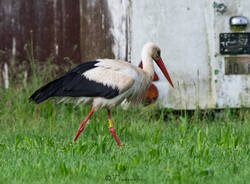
left=0, top=0, right=80, bottom=62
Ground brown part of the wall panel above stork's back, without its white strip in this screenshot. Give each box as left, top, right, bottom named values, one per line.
left=80, top=0, right=114, bottom=61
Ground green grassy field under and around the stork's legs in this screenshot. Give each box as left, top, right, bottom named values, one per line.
left=0, top=66, right=250, bottom=184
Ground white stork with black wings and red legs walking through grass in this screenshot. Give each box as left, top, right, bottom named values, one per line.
left=29, top=43, right=174, bottom=146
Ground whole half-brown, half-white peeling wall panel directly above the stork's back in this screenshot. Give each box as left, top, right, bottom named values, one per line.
left=80, top=0, right=129, bottom=61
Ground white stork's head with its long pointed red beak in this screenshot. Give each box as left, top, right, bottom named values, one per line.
left=141, top=43, right=174, bottom=87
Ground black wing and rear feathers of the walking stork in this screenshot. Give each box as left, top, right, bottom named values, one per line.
left=29, top=61, right=119, bottom=104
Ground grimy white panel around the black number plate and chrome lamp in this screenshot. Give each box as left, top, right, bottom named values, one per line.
left=214, top=0, right=250, bottom=108
